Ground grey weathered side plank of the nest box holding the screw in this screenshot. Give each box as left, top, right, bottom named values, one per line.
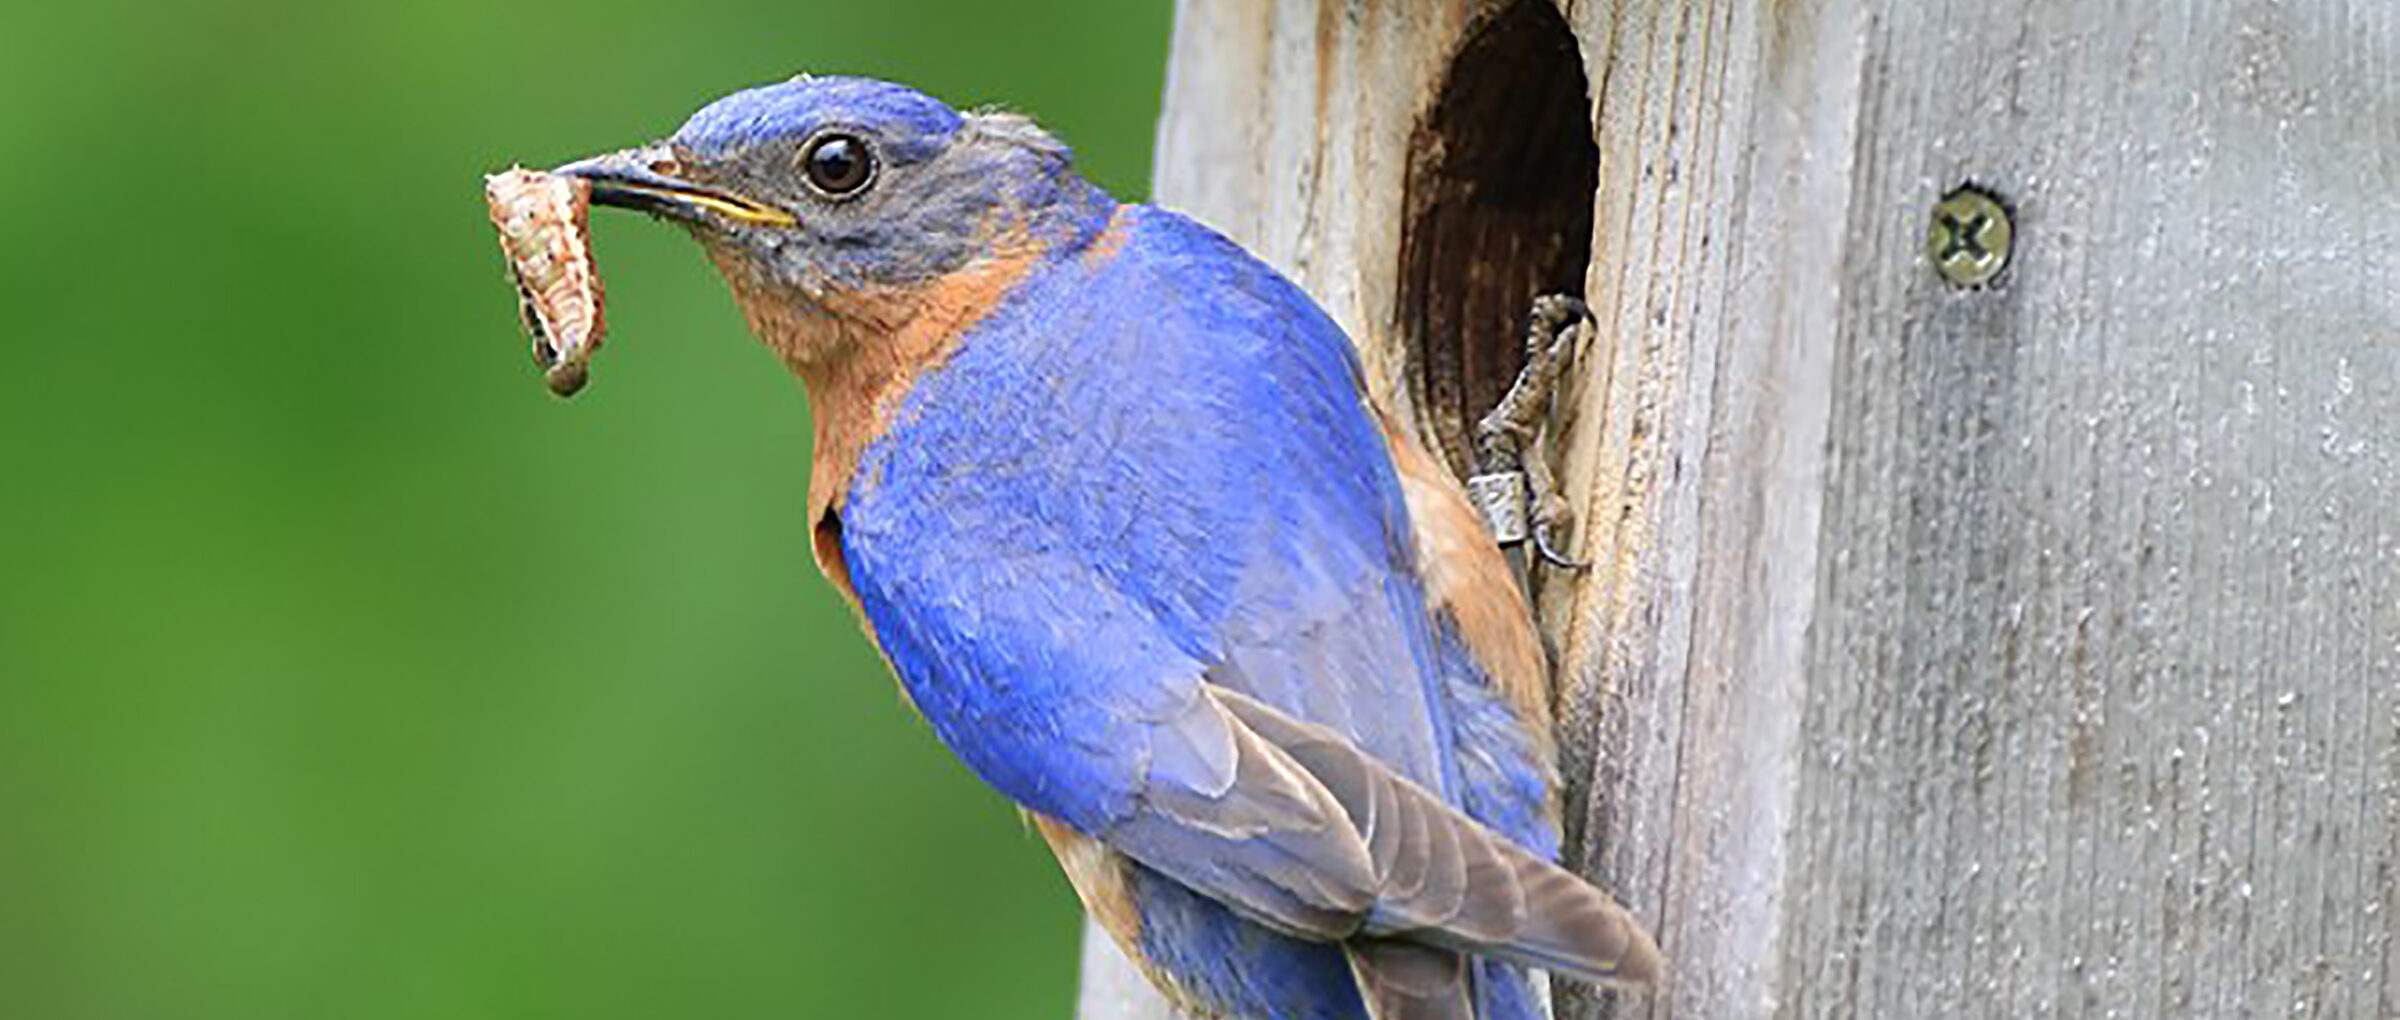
left=1778, top=0, right=2400, bottom=1018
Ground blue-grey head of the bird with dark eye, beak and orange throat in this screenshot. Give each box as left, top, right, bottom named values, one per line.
left=554, top=77, right=1114, bottom=367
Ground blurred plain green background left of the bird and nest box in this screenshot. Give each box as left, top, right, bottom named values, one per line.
left=0, top=0, right=1169, bottom=1020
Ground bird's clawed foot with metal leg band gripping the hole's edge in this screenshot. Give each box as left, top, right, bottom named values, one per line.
left=1466, top=295, right=1591, bottom=571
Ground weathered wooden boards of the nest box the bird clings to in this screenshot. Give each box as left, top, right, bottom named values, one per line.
left=1104, top=0, right=2400, bottom=1020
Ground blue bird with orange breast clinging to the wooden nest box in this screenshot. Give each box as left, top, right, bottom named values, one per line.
left=557, top=77, right=1661, bottom=1020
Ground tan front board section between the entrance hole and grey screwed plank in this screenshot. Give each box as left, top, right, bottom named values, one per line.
left=1541, top=0, right=1865, bottom=1018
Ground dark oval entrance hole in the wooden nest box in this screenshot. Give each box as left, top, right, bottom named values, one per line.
left=1399, top=0, right=1601, bottom=478
